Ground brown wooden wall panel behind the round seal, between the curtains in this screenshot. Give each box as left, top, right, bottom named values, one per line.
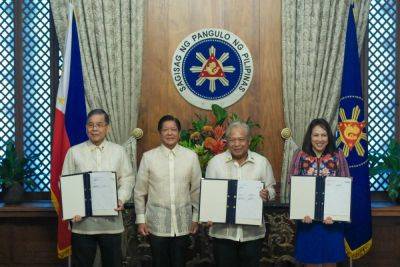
left=138, top=0, right=284, bottom=182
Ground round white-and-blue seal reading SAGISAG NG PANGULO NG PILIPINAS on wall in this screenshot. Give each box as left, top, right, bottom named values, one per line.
left=171, top=28, right=253, bottom=109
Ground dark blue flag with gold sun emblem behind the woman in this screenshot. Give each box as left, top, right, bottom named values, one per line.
left=337, top=5, right=372, bottom=259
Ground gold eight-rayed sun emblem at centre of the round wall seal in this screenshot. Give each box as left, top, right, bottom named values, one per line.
left=190, top=46, right=235, bottom=93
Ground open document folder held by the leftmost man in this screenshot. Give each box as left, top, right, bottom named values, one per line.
left=61, top=171, right=118, bottom=220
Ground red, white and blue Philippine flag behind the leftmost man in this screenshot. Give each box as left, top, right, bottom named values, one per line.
left=50, top=6, right=87, bottom=258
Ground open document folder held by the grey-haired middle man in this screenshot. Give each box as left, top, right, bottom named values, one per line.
left=199, top=179, right=263, bottom=225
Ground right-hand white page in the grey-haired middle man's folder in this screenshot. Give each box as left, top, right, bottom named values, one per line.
left=235, top=180, right=263, bottom=225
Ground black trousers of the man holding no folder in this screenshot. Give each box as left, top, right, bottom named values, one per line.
left=150, top=235, right=190, bottom=267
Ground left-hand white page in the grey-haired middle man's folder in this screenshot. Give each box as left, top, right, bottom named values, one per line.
left=199, top=179, right=228, bottom=223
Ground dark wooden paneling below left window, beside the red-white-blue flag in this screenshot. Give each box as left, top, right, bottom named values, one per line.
left=0, top=202, right=67, bottom=267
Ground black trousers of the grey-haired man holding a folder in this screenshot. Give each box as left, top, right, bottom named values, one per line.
left=213, top=238, right=263, bottom=267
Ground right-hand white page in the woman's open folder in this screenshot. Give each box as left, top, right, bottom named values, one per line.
left=324, top=176, right=352, bottom=222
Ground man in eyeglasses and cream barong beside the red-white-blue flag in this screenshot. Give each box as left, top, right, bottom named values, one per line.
left=62, top=109, right=134, bottom=267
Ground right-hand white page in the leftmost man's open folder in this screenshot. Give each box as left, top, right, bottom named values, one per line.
left=90, top=172, right=118, bottom=216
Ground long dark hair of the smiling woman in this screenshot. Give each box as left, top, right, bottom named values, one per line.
left=302, top=118, right=337, bottom=156
